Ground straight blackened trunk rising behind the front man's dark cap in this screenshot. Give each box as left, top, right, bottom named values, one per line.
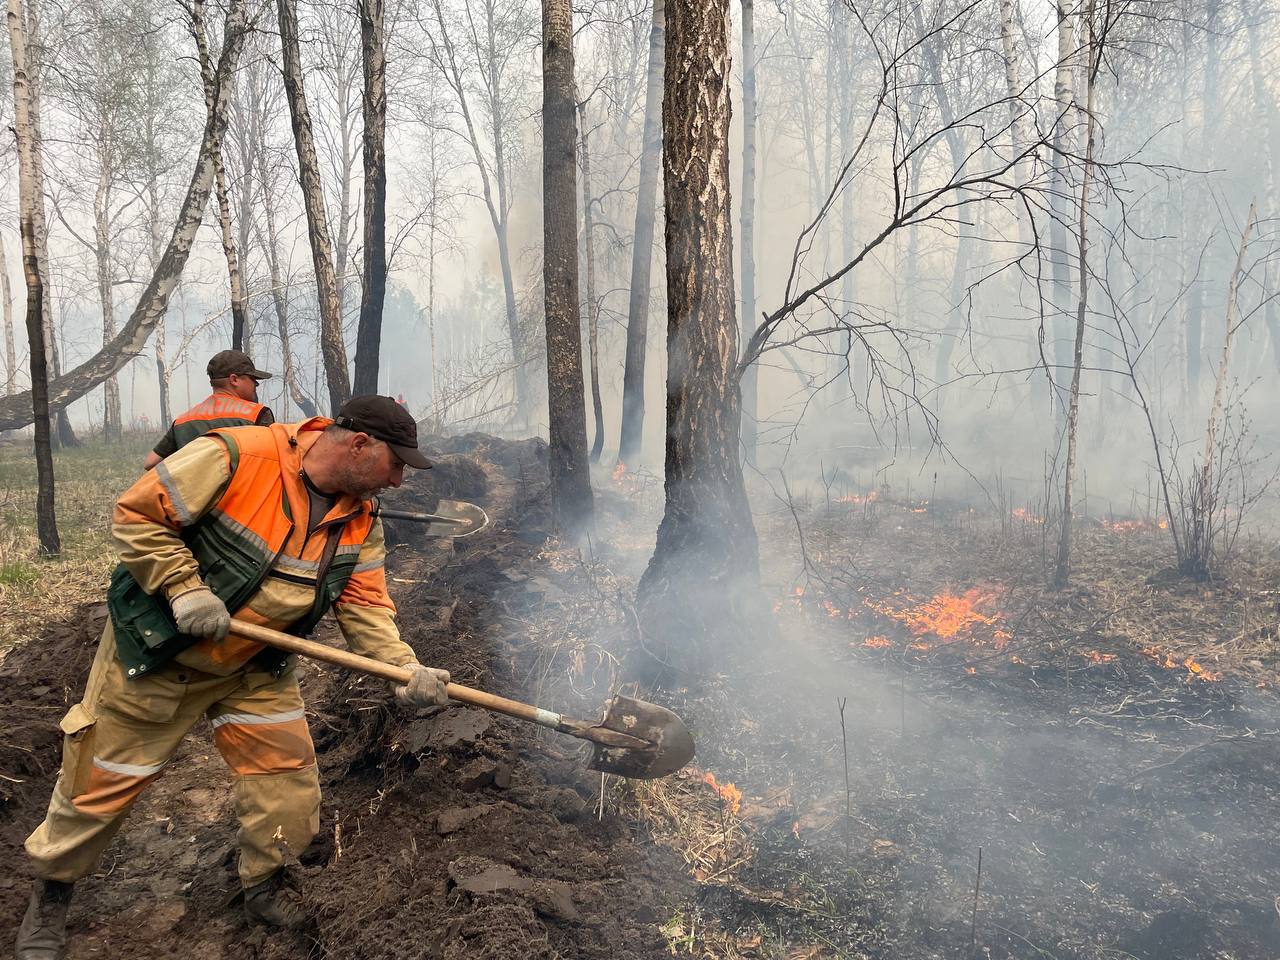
left=355, top=0, right=387, bottom=394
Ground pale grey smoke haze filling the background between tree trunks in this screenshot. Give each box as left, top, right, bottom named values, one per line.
left=5, top=0, right=1280, bottom=527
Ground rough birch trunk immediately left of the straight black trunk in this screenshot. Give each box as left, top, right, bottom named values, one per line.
left=276, top=0, right=351, bottom=413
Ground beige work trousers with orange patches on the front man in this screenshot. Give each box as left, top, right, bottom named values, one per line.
left=27, top=622, right=320, bottom=887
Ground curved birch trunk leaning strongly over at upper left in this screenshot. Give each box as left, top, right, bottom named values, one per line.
left=0, top=0, right=246, bottom=430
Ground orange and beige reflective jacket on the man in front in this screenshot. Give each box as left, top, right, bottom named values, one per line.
left=108, top=417, right=417, bottom=677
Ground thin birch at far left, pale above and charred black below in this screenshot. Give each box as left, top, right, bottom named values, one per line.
left=8, top=0, right=61, bottom=557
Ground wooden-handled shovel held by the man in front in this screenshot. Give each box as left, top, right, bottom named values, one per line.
left=230, top=620, right=694, bottom=780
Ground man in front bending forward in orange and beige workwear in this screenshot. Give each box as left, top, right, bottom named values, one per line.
left=17, top=397, right=449, bottom=960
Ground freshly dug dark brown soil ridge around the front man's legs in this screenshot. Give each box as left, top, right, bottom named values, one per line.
left=0, top=435, right=689, bottom=960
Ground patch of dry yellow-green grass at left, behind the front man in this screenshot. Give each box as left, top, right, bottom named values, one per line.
left=0, top=435, right=155, bottom=655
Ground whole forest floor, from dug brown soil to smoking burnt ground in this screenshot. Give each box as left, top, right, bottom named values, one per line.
left=0, top=436, right=1280, bottom=960
